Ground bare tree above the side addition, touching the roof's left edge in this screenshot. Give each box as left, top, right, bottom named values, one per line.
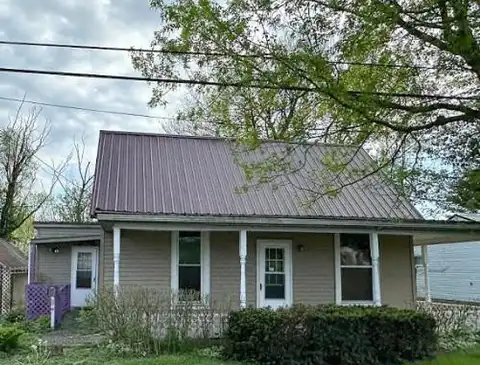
left=44, top=138, right=94, bottom=223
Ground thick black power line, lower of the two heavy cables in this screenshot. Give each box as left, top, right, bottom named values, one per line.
left=0, top=67, right=480, bottom=100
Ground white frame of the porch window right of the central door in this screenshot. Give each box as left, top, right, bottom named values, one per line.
left=334, top=232, right=375, bottom=306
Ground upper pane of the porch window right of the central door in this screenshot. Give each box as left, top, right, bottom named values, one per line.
left=340, top=234, right=371, bottom=265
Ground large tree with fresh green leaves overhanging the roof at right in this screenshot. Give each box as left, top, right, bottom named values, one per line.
left=132, top=0, right=480, bottom=213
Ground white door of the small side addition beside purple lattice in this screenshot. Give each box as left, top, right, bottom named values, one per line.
left=71, top=246, right=97, bottom=307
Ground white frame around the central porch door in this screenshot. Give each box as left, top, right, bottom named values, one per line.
left=255, top=239, right=293, bottom=308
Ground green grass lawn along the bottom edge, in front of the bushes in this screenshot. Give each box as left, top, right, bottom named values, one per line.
left=0, top=347, right=480, bottom=365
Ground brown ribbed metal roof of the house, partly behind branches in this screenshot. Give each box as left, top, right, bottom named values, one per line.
left=92, top=131, right=422, bottom=219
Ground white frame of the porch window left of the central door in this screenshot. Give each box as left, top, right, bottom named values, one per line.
left=170, top=231, right=210, bottom=298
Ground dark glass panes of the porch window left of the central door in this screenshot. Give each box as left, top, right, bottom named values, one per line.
left=178, top=232, right=202, bottom=293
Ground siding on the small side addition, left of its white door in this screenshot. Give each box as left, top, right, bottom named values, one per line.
left=36, top=244, right=72, bottom=284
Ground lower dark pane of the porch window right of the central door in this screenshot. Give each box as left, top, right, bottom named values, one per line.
left=342, top=268, right=373, bottom=301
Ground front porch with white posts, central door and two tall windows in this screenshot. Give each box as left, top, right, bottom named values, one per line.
left=106, top=224, right=415, bottom=308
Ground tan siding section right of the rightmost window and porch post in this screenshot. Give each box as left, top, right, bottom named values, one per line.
left=379, top=235, right=414, bottom=308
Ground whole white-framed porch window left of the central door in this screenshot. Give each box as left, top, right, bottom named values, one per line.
left=171, top=231, right=210, bottom=300
